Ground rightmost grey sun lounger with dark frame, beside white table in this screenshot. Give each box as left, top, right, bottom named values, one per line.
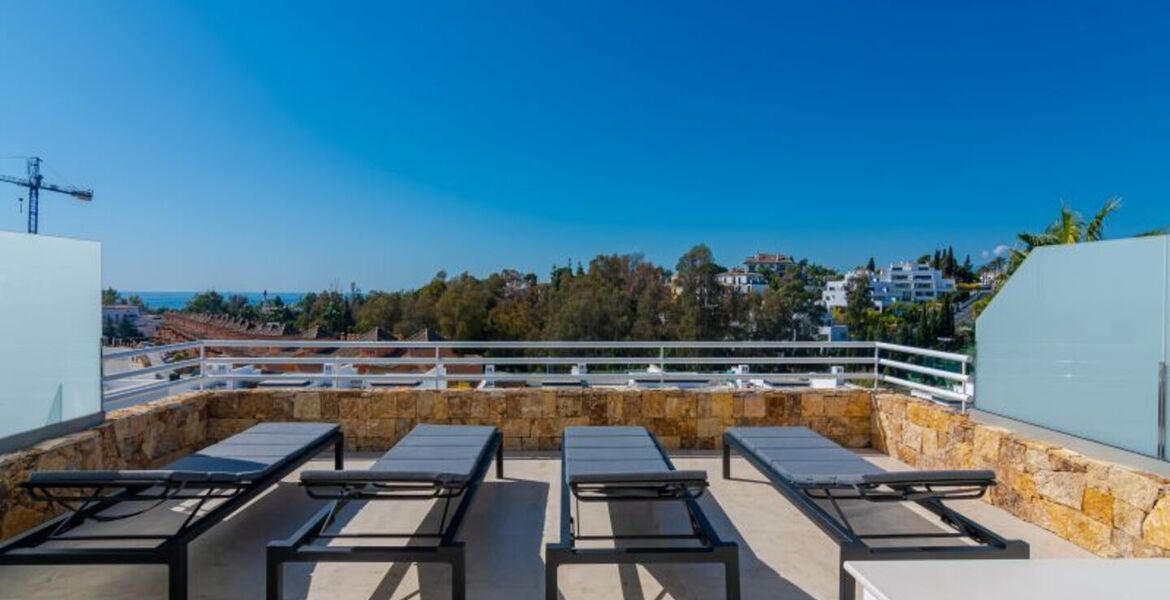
left=723, top=427, right=1028, bottom=600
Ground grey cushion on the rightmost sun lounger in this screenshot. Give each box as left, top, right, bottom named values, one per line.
left=727, top=427, right=995, bottom=487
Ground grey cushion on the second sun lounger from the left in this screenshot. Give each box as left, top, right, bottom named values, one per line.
left=301, top=423, right=496, bottom=485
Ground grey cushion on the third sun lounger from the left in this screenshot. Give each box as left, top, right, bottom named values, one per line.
left=562, top=427, right=707, bottom=485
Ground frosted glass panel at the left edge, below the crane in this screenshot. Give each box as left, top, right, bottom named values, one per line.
left=0, top=232, right=102, bottom=439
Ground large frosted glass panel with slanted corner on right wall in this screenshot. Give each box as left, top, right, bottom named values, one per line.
left=976, top=236, right=1170, bottom=455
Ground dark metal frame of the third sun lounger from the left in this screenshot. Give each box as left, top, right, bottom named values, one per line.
left=544, top=434, right=739, bottom=600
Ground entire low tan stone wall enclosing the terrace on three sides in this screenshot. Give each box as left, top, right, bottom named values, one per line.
left=0, top=388, right=1170, bottom=557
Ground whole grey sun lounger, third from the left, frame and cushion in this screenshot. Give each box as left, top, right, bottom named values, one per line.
left=544, top=427, right=739, bottom=600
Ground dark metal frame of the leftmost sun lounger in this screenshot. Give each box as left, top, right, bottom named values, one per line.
left=0, top=429, right=345, bottom=600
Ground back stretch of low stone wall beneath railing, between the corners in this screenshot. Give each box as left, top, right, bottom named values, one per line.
left=207, top=388, right=873, bottom=450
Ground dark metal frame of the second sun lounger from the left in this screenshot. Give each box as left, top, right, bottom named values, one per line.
left=267, top=432, right=504, bottom=600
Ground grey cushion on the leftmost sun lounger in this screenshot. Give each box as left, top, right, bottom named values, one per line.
left=28, top=423, right=338, bottom=487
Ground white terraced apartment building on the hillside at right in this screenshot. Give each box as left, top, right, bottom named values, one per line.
left=820, top=262, right=955, bottom=310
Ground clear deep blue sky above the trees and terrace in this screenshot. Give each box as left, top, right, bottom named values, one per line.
left=0, top=0, right=1170, bottom=290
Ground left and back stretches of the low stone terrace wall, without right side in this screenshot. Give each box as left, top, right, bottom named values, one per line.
left=0, top=389, right=873, bottom=539
